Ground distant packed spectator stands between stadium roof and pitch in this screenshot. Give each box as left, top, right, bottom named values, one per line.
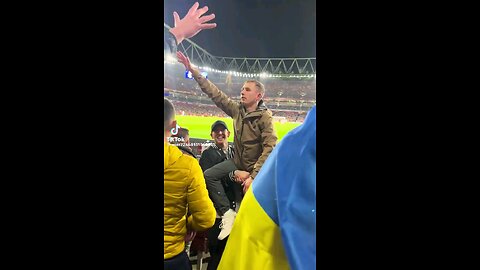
left=164, top=62, right=316, bottom=122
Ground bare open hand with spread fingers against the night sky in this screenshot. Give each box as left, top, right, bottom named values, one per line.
left=170, top=2, right=217, bottom=44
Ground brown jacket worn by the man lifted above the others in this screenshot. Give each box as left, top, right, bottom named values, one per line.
left=192, top=69, right=277, bottom=178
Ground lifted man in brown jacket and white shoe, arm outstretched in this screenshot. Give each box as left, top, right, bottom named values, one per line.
left=177, top=52, right=277, bottom=240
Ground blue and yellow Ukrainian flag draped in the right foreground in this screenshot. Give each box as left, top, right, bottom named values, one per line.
left=218, top=106, right=317, bottom=270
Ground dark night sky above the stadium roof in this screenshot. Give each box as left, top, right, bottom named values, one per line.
left=164, top=0, right=316, bottom=58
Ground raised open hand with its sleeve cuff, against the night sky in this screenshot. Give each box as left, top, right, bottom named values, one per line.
left=163, top=2, right=217, bottom=55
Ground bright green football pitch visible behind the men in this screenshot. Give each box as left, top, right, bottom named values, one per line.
left=176, top=115, right=300, bottom=142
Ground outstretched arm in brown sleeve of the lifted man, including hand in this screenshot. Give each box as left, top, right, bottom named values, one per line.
left=177, top=52, right=240, bottom=118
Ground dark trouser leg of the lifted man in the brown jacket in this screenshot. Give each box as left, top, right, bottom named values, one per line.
left=204, top=159, right=237, bottom=216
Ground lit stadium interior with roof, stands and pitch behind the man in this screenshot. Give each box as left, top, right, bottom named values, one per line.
left=164, top=21, right=316, bottom=131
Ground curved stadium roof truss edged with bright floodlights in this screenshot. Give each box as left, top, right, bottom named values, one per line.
left=164, top=23, right=317, bottom=78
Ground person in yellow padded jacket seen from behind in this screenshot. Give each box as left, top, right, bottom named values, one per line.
left=163, top=98, right=216, bottom=270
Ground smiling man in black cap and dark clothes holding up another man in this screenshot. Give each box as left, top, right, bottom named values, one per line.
left=200, top=121, right=248, bottom=270
